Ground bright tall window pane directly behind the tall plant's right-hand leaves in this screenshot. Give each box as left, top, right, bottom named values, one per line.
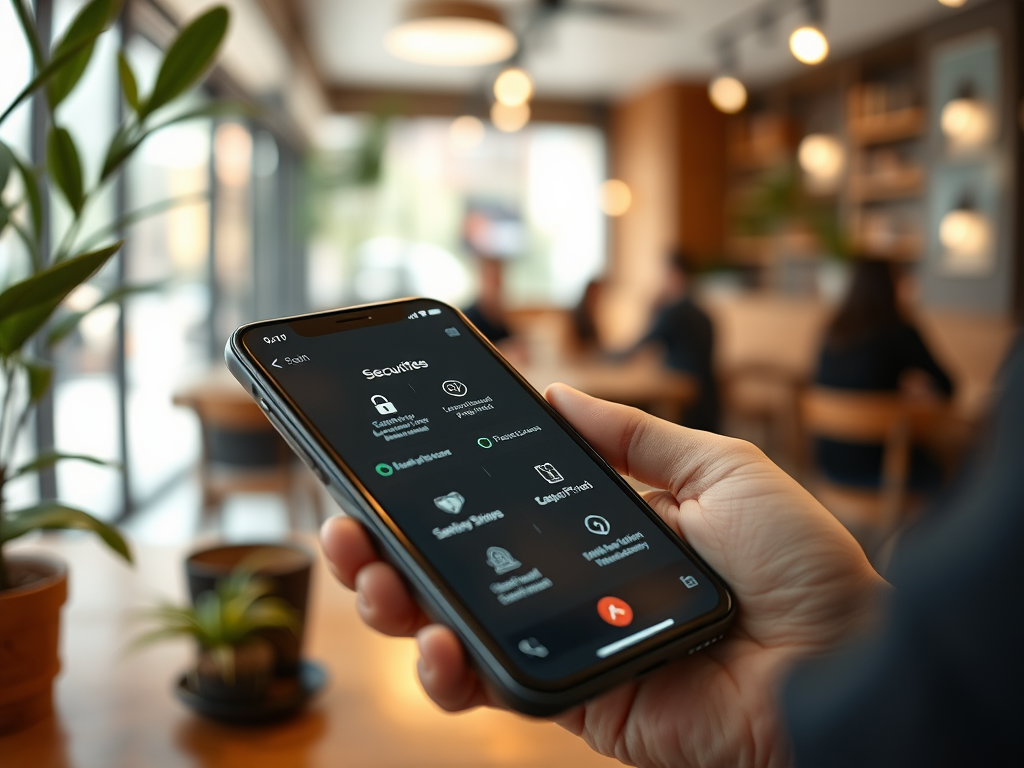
left=124, top=36, right=212, bottom=506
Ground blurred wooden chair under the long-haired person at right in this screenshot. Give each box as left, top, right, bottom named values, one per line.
left=800, top=393, right=945, bottom=550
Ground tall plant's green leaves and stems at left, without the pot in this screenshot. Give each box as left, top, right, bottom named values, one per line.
left=0, top=0, right=228, bottom=590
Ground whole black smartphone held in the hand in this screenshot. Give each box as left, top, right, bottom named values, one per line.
left=225, top=298, right=735, bottom=716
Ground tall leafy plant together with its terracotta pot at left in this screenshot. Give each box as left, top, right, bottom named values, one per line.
left=0, top=0, right=228, bottom=733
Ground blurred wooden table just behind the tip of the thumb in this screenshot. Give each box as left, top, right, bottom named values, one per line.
left=518, top=353, right=699, bottom=421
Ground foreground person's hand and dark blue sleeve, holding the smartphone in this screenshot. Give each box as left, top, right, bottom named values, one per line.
left=322, top=339, right=1024, bottom=768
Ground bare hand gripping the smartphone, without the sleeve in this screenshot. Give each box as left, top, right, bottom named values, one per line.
left=322, top=384, right=885, bottom=766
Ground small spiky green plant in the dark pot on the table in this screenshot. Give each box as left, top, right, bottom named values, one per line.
left=130, top=552, right=298, bottom=683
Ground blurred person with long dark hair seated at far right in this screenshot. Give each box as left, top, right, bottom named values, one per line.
left=815, top=258, right=953, bottom=492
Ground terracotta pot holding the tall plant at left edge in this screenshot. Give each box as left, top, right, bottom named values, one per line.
left=0, top=555, right=68, bottom=734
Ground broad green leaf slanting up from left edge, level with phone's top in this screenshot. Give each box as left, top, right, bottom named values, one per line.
left=0, top=242, right=122, bottom=356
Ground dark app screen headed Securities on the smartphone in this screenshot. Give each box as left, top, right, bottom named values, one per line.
left=244, top=302, right=720, bottom=682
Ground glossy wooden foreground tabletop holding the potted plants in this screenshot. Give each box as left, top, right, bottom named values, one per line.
left=0, top=537, right=620, bottom=768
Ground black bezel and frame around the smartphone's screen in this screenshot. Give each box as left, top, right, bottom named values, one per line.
left=225, top=298, right=735, bottom=694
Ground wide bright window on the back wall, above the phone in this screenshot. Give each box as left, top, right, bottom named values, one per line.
left=308, top=117, right=605, bottom=307
